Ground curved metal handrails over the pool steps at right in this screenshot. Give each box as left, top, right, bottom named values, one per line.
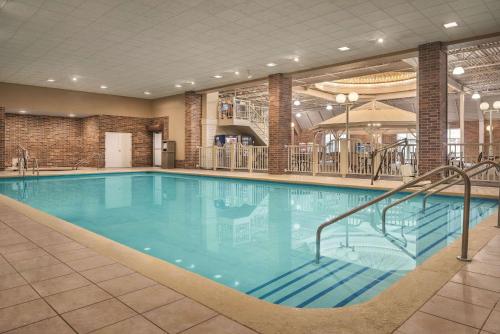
left=316, top=160, right=500, bottom=263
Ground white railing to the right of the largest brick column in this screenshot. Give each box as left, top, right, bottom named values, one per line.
left=447, top=143, right=500, bottom=181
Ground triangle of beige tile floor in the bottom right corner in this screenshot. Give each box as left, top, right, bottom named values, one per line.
left=396, top=236, right=500, bottom=334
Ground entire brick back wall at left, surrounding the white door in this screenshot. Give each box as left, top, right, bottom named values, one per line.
left=0, top=114, right=168, bottom=167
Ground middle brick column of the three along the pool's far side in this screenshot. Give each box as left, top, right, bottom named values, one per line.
left=268, top=74, right=292, bottom=174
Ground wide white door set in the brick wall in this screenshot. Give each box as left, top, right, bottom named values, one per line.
left=104, top=132, right=132, bottom=168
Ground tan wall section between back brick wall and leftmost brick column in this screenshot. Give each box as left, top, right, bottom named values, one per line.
left=152, top=94, right=186, bottom=160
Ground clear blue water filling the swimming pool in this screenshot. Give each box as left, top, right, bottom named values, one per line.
left=0, top=173, right=497, bottom=307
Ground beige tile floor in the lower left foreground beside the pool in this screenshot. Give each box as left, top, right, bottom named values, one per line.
left=0, top=206, right=256, bottom=334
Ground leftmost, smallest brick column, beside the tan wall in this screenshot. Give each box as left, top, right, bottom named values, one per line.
left=184, top=92, right=202, bottom=168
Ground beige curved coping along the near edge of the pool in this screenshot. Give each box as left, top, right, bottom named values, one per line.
left=0, top=190, right=496, bottom=333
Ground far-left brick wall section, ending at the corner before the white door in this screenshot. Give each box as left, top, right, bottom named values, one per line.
left=5, top=114, right=84, bottom=167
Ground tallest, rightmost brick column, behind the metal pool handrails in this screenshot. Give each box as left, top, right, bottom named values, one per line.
left=417, top=42, right=448, bottom=175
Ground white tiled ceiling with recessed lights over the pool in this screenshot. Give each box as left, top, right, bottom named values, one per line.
left=0, top=0, right=500, bottom=98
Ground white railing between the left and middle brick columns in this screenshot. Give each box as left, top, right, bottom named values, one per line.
left=198, top=144, right=268, bottom=172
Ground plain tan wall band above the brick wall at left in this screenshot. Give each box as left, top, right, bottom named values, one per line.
left=0, top=82, right=153, bottom=117
